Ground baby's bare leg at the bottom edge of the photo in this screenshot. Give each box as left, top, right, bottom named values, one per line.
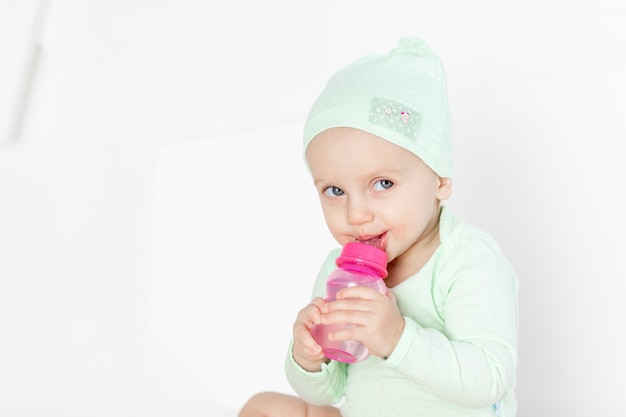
left=239, top=392, right=341, bottom=417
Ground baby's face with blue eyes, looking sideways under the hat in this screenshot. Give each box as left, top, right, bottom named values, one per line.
left=306, top=128, right=451, bottom=261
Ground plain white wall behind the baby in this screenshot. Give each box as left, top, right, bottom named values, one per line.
left=0, top=0, right=626, bottom=417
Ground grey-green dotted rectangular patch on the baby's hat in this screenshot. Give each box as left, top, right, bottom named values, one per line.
left=369, top=97, right=422, bottom=141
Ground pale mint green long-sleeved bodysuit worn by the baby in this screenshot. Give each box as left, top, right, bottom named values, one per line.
left=286, top=207, right=518, bottom=417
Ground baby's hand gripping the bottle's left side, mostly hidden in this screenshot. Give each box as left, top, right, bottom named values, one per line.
left=292, top=297, right=327, bottom=372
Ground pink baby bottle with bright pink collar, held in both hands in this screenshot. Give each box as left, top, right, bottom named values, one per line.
left=311, top=242, right=387, bottom=363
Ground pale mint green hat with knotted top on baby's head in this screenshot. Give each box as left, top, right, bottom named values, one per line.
left=304, top=37, right=453, bottom=178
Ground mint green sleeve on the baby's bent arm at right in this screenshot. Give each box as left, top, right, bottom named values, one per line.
left=385, top=232, right=517, bottom=407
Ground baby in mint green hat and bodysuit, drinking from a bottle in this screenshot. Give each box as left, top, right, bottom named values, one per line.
left=240, top=38, right=518, bottom=417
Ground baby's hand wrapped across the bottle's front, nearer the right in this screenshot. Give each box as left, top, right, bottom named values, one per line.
left=321, top=286, right=404, bottom=357
